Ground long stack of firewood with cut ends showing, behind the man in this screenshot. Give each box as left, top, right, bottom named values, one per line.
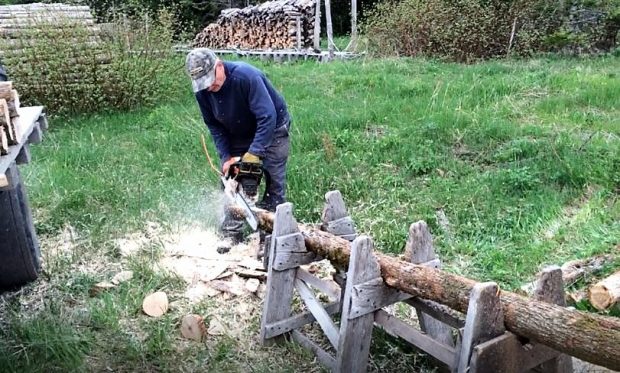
left=193, top=0, right=316, bottom=49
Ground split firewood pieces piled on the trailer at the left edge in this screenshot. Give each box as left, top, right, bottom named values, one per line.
left=0, top=82, right=20, bottom=155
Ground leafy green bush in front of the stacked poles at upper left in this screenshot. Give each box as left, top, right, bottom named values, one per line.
left=0, top=11, right=179, bottom=113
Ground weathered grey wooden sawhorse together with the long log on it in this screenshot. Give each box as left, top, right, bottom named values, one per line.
left=251, top=192, right=620, bottom=373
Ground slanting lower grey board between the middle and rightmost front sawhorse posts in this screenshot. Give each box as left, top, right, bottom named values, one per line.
left=375, top=310, right=455, bottom=368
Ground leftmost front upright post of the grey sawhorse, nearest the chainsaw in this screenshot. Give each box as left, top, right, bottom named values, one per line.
left=260, top=202, right=299, bottom=344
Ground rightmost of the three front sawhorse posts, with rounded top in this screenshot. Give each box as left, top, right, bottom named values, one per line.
left=457, top=282, right=506, bottom=372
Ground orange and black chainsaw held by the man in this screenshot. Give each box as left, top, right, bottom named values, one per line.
left=220, top=157, right=263, bottom=231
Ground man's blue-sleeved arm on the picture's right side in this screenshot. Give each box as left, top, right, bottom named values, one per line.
left=248, top=75, right=278, bottom=157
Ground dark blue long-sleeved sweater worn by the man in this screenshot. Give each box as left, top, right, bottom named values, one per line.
left=196, top=62, right=289, bottom=162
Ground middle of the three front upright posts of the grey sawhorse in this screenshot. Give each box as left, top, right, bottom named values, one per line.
left=336, top=236, right=381, bottom=372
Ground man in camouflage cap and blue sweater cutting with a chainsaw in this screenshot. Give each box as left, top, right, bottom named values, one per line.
left=186, top=48, right=290, bottom=242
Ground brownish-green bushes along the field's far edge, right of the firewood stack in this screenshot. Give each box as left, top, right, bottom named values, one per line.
left=362, top=0, right=619, bottom=62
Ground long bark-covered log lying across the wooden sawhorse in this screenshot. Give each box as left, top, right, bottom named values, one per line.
left=255, top=210, right=620, bottom=370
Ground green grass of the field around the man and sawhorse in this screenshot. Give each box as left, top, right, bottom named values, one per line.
left=0, top=53, right=620, bottom=371
